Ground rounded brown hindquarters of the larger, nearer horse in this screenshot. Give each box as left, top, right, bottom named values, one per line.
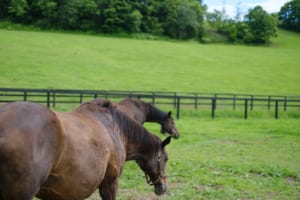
left=0, top=102, right=62, bottom=200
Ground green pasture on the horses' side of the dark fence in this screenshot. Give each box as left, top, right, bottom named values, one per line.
left=113, top=118, right=300, bottom=200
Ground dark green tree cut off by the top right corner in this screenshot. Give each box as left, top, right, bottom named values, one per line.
left=279, top=0, right=300, bottom=32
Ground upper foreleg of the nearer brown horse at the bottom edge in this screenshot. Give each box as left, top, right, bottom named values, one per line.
left=99, top=178, right=118, bottom=200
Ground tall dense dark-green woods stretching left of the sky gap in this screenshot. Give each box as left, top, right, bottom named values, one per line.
left=0, top=0, right=203, bottom=39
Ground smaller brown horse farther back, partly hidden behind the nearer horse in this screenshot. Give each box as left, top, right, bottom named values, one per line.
left=114, top=98, right=179, bottom=139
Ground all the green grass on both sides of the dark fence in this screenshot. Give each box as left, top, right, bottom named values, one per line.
left=0, top=26, right=300, bottom=200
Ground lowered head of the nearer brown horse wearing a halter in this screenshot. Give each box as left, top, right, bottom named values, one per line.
left=137, top=137, right=171, bottom=195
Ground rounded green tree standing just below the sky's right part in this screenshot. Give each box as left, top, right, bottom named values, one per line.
left=245, top=6, right=277, bottom=44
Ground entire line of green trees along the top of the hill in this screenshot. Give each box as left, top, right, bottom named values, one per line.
left=0, top=0, right=300, bottom=44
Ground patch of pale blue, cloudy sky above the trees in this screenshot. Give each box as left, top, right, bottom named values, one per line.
left=203, top=0, right=290, bottom=17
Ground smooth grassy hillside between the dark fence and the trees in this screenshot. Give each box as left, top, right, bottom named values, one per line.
left=0, top=29, right=300, bottom=95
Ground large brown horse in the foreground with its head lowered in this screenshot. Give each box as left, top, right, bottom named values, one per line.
left=0, top=100, right=170, bottom=200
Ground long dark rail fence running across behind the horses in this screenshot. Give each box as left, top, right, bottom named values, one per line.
left=0, top=88, right=300, bottom=119
